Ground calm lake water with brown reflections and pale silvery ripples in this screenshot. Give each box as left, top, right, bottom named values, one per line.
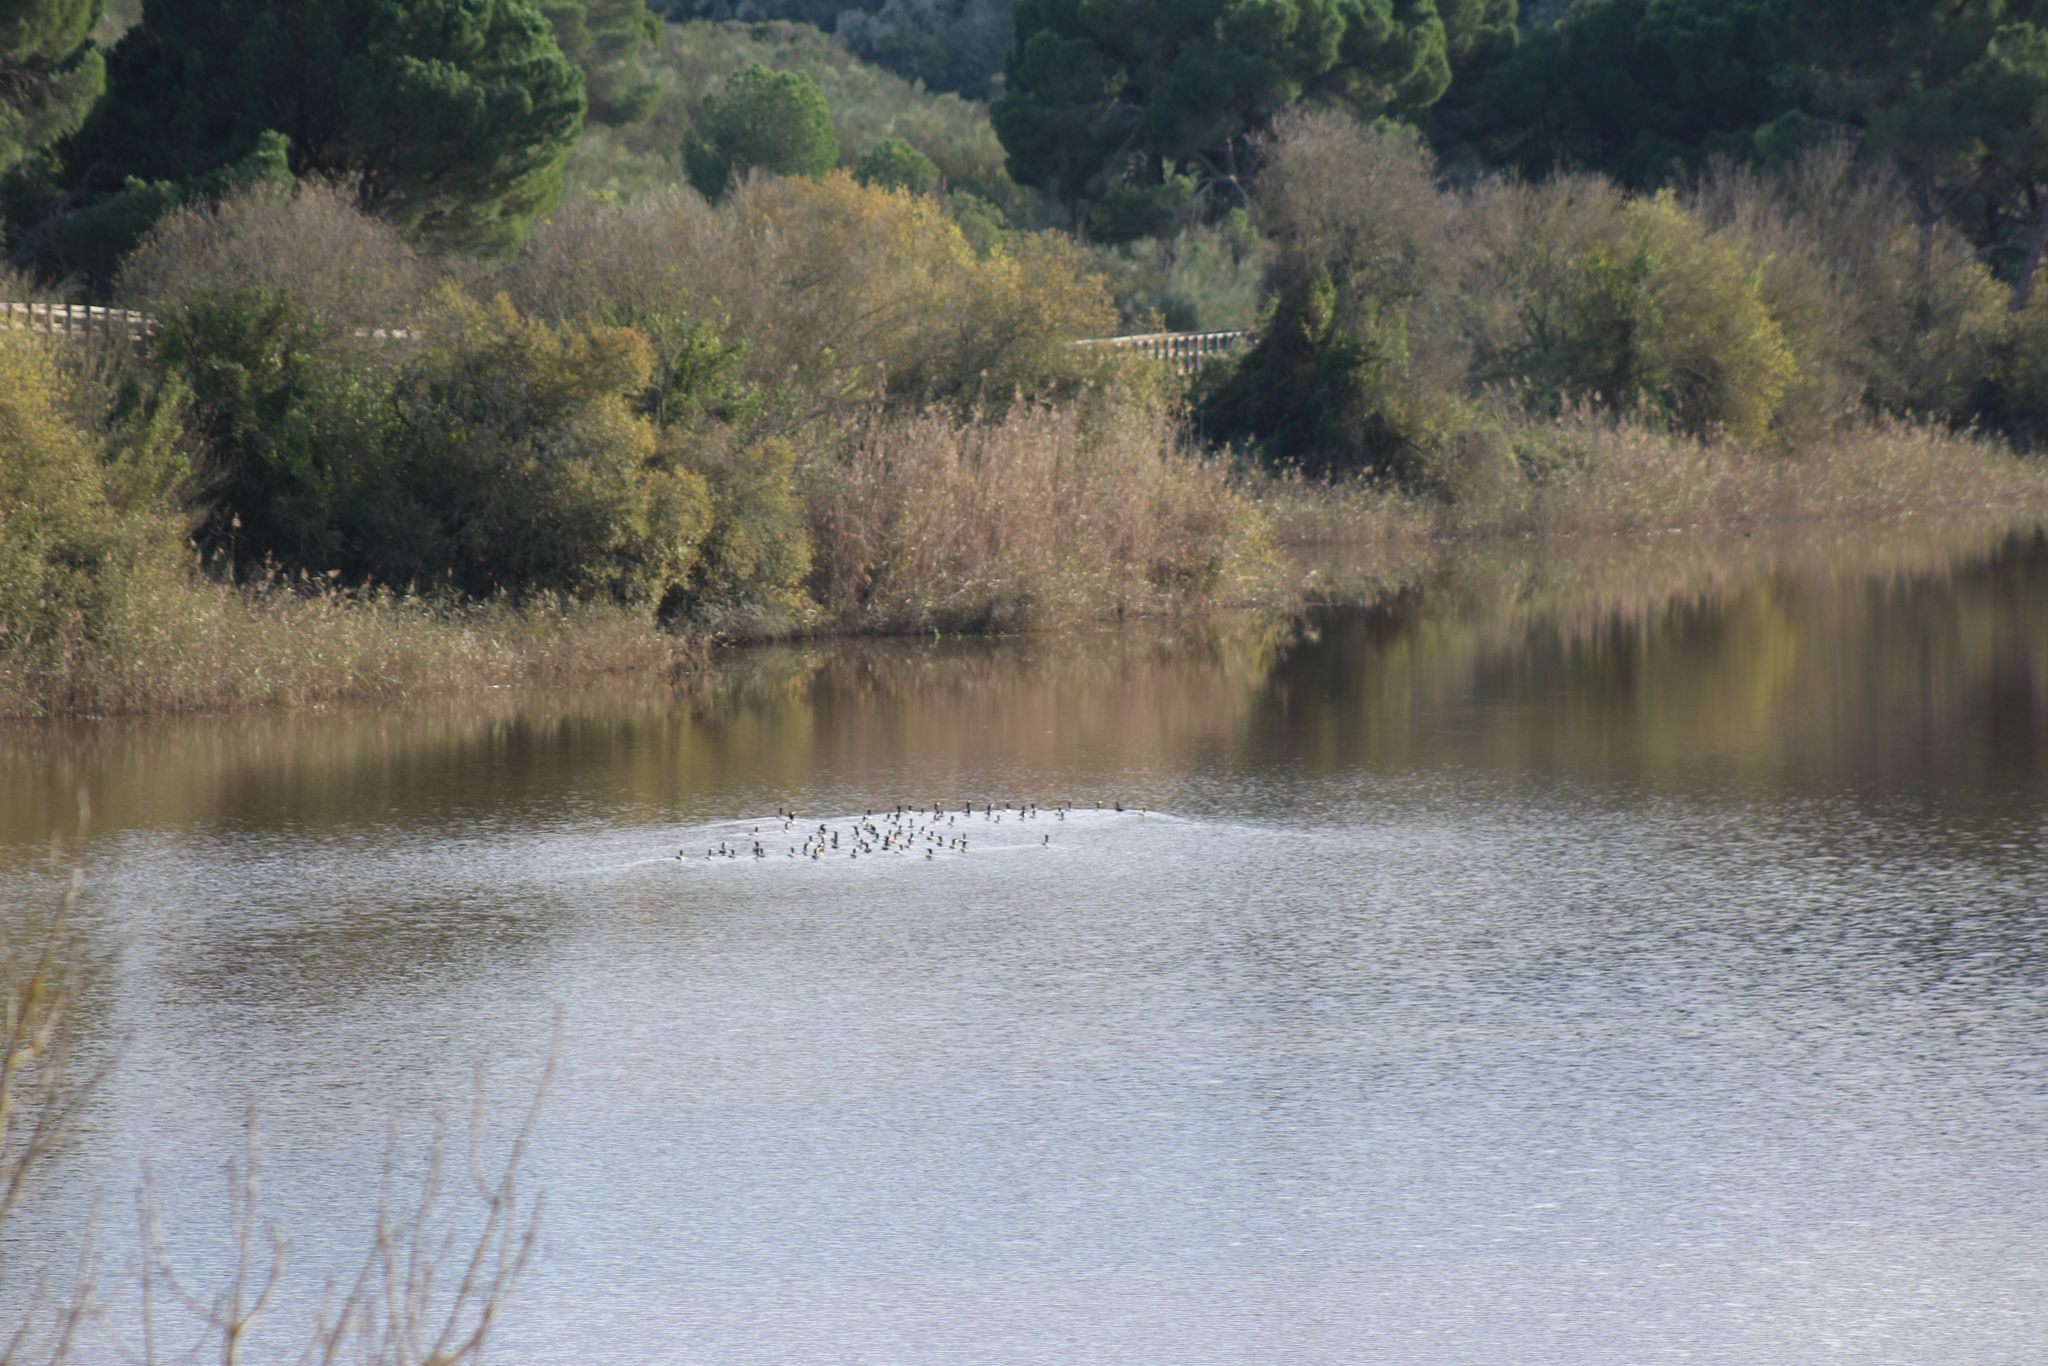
left=0, top=535, right=2048, bottom=1366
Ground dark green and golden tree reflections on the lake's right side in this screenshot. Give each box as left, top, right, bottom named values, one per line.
left=1274, top=524, right=2048, bottom=819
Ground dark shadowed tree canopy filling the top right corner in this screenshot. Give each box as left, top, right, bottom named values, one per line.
left=1475, top=0, right=2048, bottom=299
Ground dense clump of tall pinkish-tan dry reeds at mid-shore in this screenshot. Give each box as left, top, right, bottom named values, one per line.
left=805, top=403, right=1278, bottom=631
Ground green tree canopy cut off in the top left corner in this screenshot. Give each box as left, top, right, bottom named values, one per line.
left=0, top=0, right=106, bottom=176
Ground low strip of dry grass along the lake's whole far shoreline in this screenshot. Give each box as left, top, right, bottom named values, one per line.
left=0, top=496, right=2048, bottom=731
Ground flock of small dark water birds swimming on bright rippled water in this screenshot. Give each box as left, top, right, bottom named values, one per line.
left=676, top=801, right=1147, bottom=862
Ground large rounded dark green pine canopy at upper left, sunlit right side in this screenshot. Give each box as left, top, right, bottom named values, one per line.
left=78, top=0, right=584, bottom=250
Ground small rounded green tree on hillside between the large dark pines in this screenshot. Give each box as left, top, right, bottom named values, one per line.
left=682, top=61, right=840, bottom=199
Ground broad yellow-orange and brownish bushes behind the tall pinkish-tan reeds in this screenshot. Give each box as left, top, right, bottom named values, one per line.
left=506, top=172, right=1128, bottom=432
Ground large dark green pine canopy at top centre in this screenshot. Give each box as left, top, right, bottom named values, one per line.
left=993, top=0, right=1482, bottom=219
